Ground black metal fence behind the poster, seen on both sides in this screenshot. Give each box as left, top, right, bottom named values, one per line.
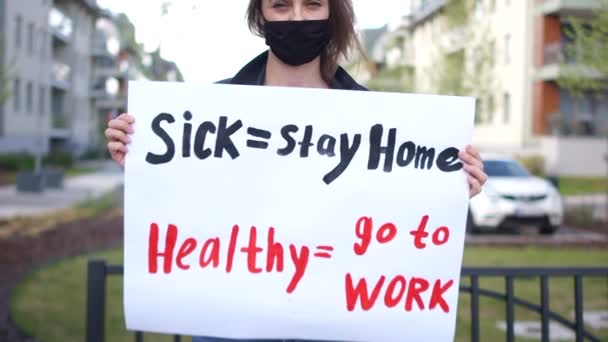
left=86, top=260, right=608, bottom=342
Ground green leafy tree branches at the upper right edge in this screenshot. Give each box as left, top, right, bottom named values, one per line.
left=558, top=0, right=608, bottom=95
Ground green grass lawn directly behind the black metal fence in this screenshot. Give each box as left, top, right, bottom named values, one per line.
left=10, top=247, right=608, bottom=342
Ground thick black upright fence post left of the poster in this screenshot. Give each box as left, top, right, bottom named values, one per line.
left=86, top=260, right=106, bottom=342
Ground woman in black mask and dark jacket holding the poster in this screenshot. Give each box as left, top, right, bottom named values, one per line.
left=106, top=0, right=487, bottom=342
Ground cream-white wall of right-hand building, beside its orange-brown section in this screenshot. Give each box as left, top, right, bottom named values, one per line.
left=409, top=0, right=534, bottom=150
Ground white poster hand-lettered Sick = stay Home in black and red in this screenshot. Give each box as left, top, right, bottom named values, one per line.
left=124, top=82, right=474, bottom=342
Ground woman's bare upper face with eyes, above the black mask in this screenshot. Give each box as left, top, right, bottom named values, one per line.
left=262, top=0, right=328, bottom=21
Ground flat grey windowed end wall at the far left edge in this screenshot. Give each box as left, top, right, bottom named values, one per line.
left=0, top=0, right=51, bottom=154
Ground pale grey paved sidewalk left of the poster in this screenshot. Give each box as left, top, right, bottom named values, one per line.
left=0, top=161, right=123, bottom=220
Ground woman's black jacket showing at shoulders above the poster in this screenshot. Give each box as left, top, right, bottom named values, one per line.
left=217, top=51, right=367, bottom=91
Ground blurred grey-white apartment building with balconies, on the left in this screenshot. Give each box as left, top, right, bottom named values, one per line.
left=0, top=0, right=126, bottom=155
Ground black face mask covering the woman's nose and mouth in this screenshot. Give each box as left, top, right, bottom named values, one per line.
left=264, top=20, right=329, bottom=66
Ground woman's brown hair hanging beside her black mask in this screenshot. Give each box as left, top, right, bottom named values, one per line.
left=247, top=0, right=362, bottom=83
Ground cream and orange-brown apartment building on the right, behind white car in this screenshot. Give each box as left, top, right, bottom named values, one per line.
left=382, top=0, right=608, bottom=175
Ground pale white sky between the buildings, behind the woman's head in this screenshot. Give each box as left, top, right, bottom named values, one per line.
left=97, top=0, right=409, bottom=83
